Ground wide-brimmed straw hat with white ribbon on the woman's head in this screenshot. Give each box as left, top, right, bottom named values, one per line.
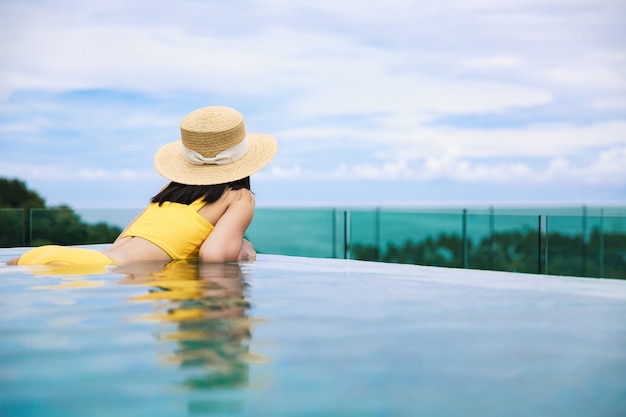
left=154, top=106, right=278, bottom=185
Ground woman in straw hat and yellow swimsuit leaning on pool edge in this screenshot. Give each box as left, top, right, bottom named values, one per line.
left=8, top=106, right=278, bottom=265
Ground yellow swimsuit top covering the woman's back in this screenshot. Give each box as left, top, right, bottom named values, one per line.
left=122, top=198, right=214, bottom=259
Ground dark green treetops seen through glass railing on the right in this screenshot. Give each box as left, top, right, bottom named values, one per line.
left=351, top=229, right=626, bottom=279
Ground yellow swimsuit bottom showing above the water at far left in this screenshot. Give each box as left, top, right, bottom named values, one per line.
left=17, top=245, right=113, bottom=266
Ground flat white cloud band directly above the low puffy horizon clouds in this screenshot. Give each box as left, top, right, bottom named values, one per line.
left=277, top=120, right=626, bottom=160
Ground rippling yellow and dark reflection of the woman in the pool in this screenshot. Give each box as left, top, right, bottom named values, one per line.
left=115, top=261, right=263, bottom=411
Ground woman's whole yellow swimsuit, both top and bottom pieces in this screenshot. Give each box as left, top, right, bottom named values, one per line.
left=18, top=198, right=213, bottom=265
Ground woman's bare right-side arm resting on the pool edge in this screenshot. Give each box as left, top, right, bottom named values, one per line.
left=200, top=190, right=254, bottom=262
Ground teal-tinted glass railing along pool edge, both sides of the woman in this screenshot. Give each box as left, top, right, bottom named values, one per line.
left=0, top=208, right=626, bottom=278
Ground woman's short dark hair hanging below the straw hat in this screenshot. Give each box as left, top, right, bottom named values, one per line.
left=152, top=177, right=250, bottom=205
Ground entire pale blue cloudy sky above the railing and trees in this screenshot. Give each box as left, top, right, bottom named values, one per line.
left=0, top=0, right=626, bottom=208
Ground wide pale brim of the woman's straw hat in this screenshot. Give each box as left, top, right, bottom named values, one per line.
left=154, top=133, right=278, bottom=185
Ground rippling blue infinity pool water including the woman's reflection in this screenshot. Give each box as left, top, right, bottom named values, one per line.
left=0, top=248, right=626, bottom=417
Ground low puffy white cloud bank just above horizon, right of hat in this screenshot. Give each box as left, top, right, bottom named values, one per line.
left=258, top=146, right=626, bottom=186
